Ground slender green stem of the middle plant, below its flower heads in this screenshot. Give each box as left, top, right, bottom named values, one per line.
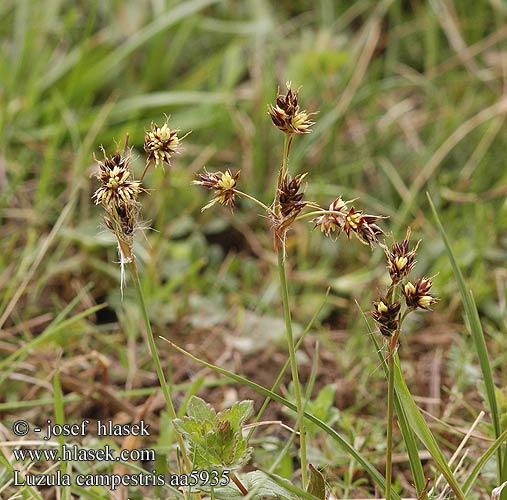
left=278, top=252, right=307, bottom=489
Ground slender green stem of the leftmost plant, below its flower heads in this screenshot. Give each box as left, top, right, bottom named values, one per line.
left=129, top=260, right=190, bottom=470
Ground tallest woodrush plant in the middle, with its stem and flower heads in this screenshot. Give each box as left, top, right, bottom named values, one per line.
left=194, top=83, right=384, bottom=489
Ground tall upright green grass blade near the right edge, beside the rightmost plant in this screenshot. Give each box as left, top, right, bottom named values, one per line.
left=427, top=194, right=505, bottom=483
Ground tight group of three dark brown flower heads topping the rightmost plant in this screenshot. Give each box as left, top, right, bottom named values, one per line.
left=371, top=229, right=438, bottom=340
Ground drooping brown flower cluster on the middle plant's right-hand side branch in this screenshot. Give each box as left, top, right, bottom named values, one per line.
left=313, top=197, right=386, bottom=247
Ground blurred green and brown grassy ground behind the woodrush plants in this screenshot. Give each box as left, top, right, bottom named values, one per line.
left=0, top=0, right=507, bottom=499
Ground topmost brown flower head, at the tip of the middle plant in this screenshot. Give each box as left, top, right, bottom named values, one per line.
left=268, top=82, right=315, bottom=134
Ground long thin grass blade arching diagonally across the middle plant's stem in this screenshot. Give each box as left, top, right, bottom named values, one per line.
left=160, top=337, right=400, bottom=500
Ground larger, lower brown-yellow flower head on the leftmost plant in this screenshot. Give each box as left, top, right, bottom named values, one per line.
left=93, top=150, right=143, bottom=208
